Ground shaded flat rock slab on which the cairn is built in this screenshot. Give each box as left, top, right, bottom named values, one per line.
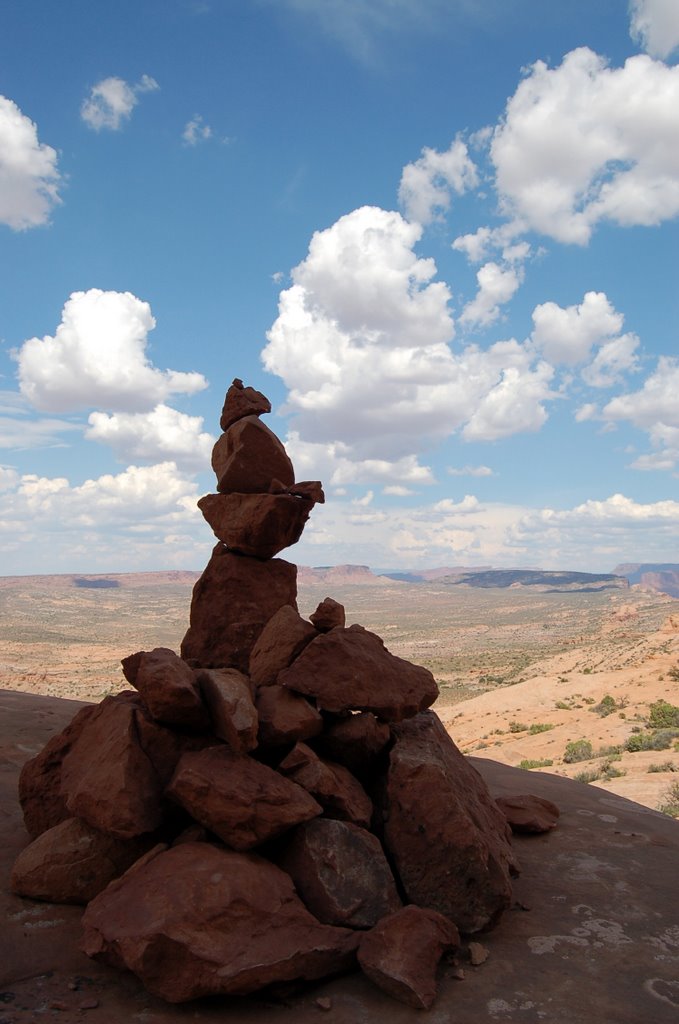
left=5, top=690, right=679, bottom=1024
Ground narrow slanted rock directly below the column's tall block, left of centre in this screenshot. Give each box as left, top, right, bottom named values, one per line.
left=196, top=669, right=258, bottom=754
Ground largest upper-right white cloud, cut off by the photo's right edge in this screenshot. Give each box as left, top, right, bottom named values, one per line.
left=491, top=47, right=679, bottom=245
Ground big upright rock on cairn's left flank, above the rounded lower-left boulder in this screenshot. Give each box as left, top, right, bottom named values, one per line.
left=61, top=696, right=163, bottom=839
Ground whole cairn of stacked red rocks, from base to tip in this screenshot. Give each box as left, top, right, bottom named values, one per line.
left=12, top=380, right=522, bottom=1008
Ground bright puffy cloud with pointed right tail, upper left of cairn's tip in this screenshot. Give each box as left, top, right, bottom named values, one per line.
left=15, top=288, right=207, bottom=413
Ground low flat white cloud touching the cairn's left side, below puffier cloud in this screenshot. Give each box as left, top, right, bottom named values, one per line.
left=85, top=403, right=216, bottom=472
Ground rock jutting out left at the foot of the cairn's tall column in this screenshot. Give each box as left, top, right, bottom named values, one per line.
left=134, top=647, right=210, bottom=730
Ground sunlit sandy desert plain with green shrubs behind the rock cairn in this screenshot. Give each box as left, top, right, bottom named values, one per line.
left=0, top=566, right=679, bottom=814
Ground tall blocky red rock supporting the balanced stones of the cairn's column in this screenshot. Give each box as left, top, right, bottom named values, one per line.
left=181, top=544, right=297, bottom=672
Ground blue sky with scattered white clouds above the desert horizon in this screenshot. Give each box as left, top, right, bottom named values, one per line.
left=0, top=0, right=679, bottom=575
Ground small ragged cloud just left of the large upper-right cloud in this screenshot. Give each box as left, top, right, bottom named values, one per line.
left=398, top=136, right=478, bottom=224
